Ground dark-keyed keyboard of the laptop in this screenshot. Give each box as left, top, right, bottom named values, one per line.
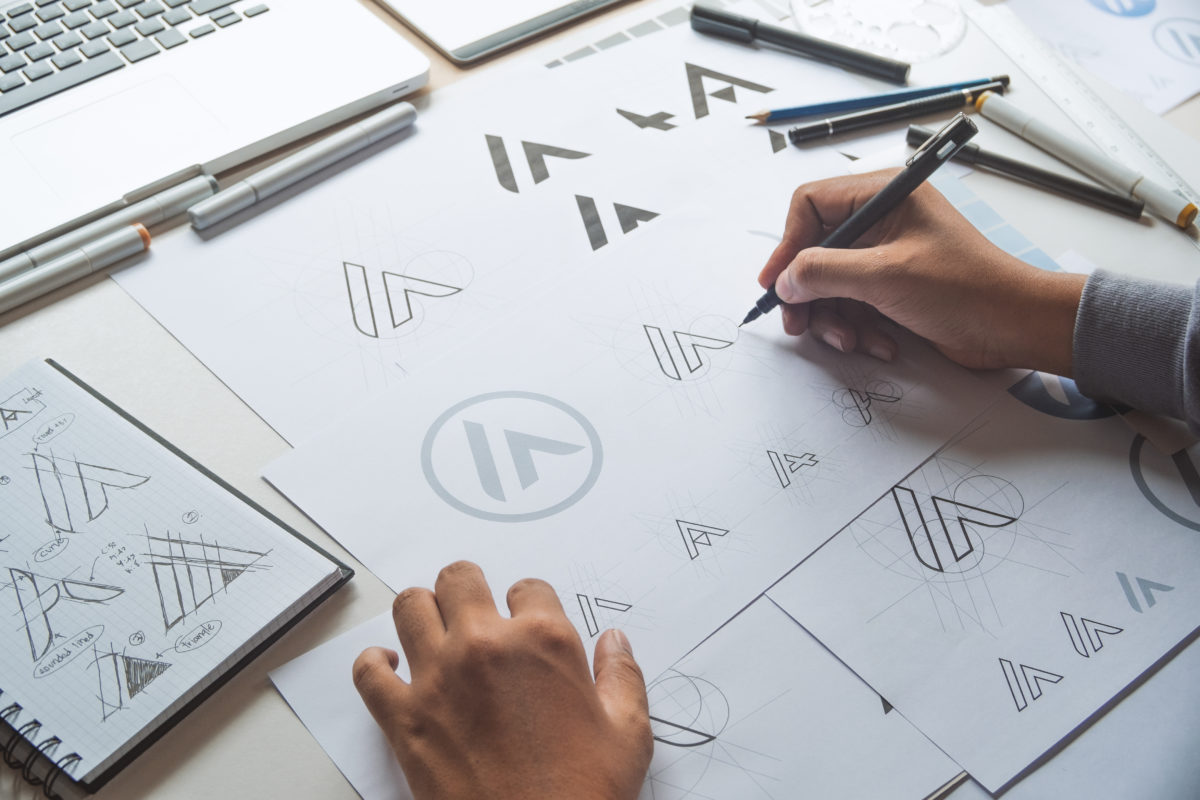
left=0, top=0, right=268, bottom=116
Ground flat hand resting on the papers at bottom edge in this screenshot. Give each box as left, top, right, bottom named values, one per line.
left=354, top=561, right=654, bottom=800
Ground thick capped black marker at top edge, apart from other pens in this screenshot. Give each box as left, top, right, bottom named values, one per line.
left=691, top=2, right=910, bottom=84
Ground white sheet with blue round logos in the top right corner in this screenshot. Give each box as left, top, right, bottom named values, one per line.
left=1006, top=0, right=1200, bottom=114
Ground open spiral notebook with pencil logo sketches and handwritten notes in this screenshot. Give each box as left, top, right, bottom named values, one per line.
left=0, top=361, right=353, bottom=796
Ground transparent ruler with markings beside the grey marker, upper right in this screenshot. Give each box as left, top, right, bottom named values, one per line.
left=962, top=1, right=1200, bottom=248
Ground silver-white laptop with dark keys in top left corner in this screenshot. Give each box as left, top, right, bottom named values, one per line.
left=0, top=0, right=430, bottom=253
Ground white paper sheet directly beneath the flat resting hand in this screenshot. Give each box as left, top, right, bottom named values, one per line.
left=271, top=600, right=959, bottom=800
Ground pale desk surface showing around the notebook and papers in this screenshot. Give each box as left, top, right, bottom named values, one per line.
left=0, top=4, right=1200, bottom=800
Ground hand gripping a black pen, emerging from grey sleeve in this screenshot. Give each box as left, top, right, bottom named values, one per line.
left=758, top=170, right=1086, bottom=377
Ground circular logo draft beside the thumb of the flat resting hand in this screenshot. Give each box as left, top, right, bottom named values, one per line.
left=646, top=669, right=730, bottom=747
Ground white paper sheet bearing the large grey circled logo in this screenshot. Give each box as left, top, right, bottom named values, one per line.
left=265, top=206, right=992, bottom=673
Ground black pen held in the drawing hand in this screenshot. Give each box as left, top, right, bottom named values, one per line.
left=738, top=112, right=979, bottom=327
